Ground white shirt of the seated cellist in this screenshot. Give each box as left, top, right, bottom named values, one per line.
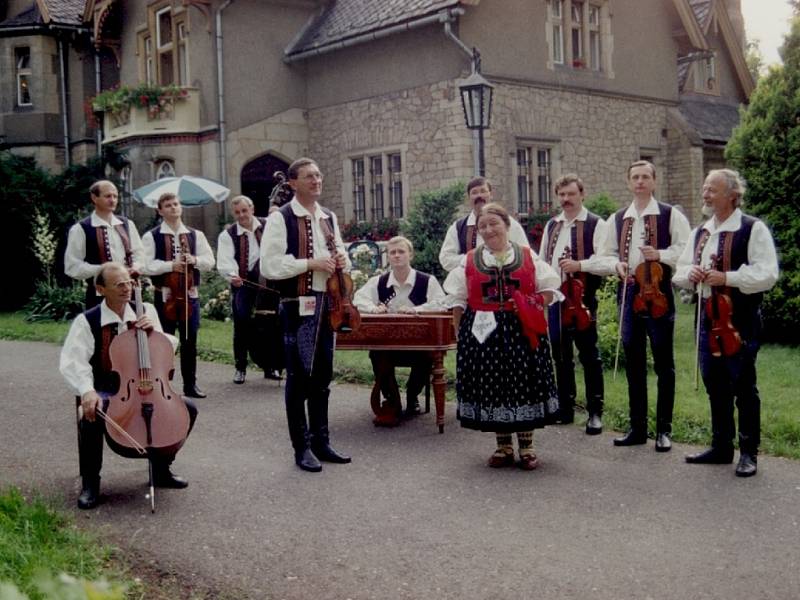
left=58, top=300, right=178, bottom=396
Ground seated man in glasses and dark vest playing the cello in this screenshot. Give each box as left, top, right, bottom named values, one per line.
left=59, top=263, right=197, bottom=509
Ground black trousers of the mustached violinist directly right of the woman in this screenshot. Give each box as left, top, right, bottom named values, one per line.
left=548, top=304, right=605, bottom=416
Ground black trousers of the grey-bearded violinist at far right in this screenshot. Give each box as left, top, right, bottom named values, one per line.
left=700, top=315, right=761, bottom=454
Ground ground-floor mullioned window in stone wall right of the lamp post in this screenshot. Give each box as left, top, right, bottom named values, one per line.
left=516, top=145, right=554, bottom=215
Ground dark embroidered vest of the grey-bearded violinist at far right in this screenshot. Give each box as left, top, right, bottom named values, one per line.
left=694, top=214, right=764, bottom=340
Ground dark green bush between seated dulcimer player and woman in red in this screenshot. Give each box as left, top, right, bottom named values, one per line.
left=402, top=182, right=466, bottom=281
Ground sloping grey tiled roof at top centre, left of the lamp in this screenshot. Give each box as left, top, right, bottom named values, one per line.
left=285, top=0, right=462, bottom=57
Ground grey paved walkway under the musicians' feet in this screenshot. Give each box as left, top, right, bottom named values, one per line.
left=0, top=341, right=800, bottom=600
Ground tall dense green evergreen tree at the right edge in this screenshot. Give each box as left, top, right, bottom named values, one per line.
left=725, top=17, right=800, bottom=343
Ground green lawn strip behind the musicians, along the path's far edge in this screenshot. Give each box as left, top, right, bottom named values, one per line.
left=0, top=304, right=800, bottom=459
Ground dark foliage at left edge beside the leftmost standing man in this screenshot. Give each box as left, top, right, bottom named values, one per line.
left=0, top=151, right=103, bottom=310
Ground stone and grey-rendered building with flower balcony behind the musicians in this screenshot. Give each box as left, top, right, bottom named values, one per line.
left=0, top=0, right=753, bottom=230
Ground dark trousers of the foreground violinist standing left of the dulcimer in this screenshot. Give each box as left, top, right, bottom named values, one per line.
left=279, top=294, right=334, bottom=453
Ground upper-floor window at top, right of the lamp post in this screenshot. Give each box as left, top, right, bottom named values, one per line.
left=545, top=0, right=613, bottom=77
